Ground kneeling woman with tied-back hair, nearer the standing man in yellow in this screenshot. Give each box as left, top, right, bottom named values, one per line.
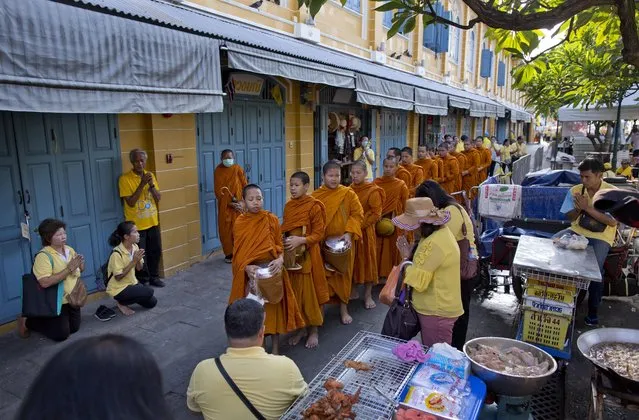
left=107, top=222, right=158, bottom=315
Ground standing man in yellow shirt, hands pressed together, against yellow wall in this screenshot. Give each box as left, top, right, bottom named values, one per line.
left=118, top=149, right=164, bottom=287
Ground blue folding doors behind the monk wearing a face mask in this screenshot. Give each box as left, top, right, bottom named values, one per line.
left=197, top=100, right=286, bottom=253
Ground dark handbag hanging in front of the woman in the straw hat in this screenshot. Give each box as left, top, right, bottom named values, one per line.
left=382, top=266, right=421, bottom=340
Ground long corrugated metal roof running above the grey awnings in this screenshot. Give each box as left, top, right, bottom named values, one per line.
left=65, top=0, right=499, bottom=104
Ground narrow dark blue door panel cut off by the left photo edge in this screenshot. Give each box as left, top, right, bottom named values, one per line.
left=0, top=113, right=31, bottom=323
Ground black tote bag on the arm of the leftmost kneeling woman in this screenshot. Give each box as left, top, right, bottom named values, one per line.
left=22, top=252, right=64, bottom=318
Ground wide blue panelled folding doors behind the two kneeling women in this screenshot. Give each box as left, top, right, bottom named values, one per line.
left=0, top=113, right=122, bottom=322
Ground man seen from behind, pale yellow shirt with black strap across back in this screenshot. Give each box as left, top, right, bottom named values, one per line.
left=186, top=299, right=308, bottom=420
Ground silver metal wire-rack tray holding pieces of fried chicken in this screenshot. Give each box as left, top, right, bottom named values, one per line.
left=282, top=331, right=418, bottom=420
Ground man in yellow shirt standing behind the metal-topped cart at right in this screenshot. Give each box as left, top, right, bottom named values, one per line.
left=555, top=159, right=617, bottom=326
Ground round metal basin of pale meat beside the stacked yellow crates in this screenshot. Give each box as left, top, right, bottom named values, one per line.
left=464, top=337, right=557, bottom=397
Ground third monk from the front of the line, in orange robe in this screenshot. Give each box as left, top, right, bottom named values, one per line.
left=312, top=161, right=364, bottom=324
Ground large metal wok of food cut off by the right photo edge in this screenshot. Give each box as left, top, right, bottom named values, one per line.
left=577, top=328, right=639, bottom=393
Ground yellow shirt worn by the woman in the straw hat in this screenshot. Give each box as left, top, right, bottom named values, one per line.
left=404, top=226, right=464, bottom=318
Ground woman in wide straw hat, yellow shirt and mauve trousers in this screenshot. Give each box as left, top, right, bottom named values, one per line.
left=393, top=197, right=464, bottom=346
